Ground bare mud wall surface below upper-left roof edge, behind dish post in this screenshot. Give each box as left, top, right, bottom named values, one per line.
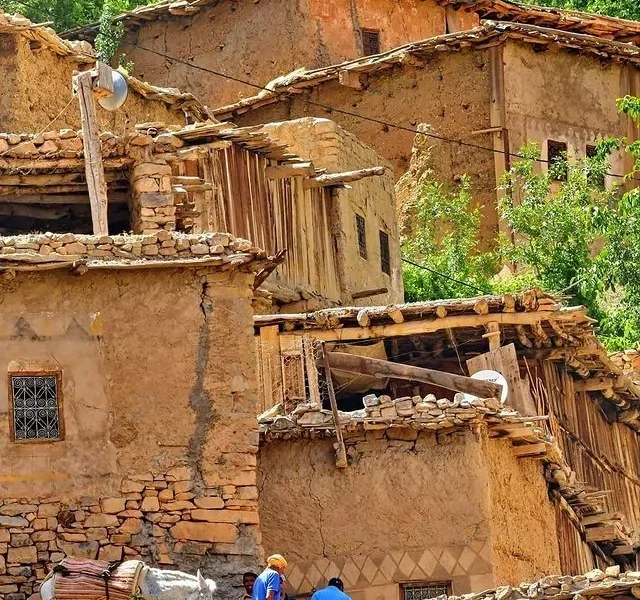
left=0, top=35, right=186, bottom=133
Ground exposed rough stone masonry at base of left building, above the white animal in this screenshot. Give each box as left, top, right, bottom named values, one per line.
left=0, top=466, right=259, bottom=600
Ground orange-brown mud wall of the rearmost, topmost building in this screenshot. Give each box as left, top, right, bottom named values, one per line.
left=121, top=0, right=445, bottom=106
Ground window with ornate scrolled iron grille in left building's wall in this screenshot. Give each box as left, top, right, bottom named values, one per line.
left=9, top=373, right=62, bottom=442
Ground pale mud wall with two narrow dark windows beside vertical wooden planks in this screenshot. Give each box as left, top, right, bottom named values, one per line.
left=264, top=118, right=404, bottom=305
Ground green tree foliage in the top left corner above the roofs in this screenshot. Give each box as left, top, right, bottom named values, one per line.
left=0, top=0, right=152, bottom=31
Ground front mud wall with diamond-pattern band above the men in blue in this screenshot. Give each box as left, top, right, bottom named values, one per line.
left=259, top=431, right=494, bottom=600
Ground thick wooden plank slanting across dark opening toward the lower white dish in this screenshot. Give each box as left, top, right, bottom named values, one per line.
left=328, top=352, right=502, bottom=398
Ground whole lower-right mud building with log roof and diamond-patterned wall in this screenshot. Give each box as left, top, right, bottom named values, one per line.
left=255, top=290, right=640, bottom=600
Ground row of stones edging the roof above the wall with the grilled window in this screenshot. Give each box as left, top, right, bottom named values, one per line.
left=0, top=231, right=266, bottom=269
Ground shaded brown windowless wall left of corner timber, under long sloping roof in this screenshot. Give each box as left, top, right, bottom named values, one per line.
left=234, top=50, right=498, bottom=238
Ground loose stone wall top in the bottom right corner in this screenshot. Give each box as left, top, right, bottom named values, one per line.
left=449, top=565, right=640, bottom=600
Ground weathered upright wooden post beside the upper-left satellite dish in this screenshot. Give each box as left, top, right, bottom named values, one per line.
left=75, top=65, right=109, bottom=235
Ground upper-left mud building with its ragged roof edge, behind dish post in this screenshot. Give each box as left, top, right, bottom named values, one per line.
left=0, top=11, right=208, bottom=133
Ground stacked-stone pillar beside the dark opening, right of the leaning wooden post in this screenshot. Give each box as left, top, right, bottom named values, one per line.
left=131, top=159, right=176, bottom=233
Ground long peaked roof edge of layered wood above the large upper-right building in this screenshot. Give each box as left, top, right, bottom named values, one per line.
left=212, top=21, right=640, bottom=119
